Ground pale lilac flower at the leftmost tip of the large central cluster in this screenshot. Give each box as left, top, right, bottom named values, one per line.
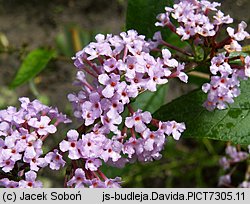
left=59, top=130, right=81, bottom=159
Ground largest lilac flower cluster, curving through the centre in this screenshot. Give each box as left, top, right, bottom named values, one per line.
left=63, top=30, right=187, bottom=186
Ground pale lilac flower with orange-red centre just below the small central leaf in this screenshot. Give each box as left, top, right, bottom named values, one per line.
left=125, top=110, right=152, bottom=133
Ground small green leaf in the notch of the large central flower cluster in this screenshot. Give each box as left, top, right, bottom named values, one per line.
left=132, top=85, right=168, bottom=113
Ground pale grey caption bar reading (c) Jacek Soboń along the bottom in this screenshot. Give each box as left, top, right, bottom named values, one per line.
left=0, top=188, right=250, bottom=204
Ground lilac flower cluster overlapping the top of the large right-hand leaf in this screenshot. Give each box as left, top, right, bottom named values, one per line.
left=202, top=53, right=249, bottom=111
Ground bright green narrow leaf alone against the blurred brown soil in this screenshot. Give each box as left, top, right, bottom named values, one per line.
left=10, top=49, right=55, bottom=88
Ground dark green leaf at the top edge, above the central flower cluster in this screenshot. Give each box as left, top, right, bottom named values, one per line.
left=126, top=0, right=173, bottom=38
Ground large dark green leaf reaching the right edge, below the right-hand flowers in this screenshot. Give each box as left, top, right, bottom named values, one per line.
left=154, top=81, right=250, bottom=144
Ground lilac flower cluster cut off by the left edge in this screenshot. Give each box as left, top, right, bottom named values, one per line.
left=0, top=97, right=70, bottom=187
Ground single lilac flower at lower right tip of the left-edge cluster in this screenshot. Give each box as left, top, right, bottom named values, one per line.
left=44, top=149, right=66, bottom=170
